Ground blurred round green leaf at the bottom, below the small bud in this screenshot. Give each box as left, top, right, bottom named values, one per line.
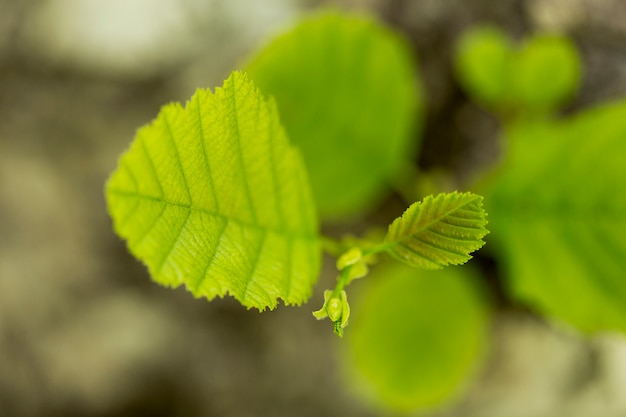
left=342, top=263, right=489, bottom=412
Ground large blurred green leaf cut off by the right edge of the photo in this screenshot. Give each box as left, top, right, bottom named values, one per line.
left=481, top=102, right=626, bottom=331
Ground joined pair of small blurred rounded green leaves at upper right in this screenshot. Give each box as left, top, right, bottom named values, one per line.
left=456, top=27, right=581, bottom=113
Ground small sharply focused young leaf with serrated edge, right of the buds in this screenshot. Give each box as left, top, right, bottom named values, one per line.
left=385, top=192, right=489, bottom=269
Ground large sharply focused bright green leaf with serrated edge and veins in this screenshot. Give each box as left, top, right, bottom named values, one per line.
left=106, top=72, right=320, bottom=310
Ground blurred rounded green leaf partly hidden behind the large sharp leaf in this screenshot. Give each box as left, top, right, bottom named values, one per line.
left=247, top=13, right=421, bottom=218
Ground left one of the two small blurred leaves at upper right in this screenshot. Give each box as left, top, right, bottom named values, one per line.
left=456, top=27, right=515, bottom=107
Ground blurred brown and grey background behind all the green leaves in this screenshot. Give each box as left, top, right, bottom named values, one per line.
left=0, top=0, right=626, bottom=417
